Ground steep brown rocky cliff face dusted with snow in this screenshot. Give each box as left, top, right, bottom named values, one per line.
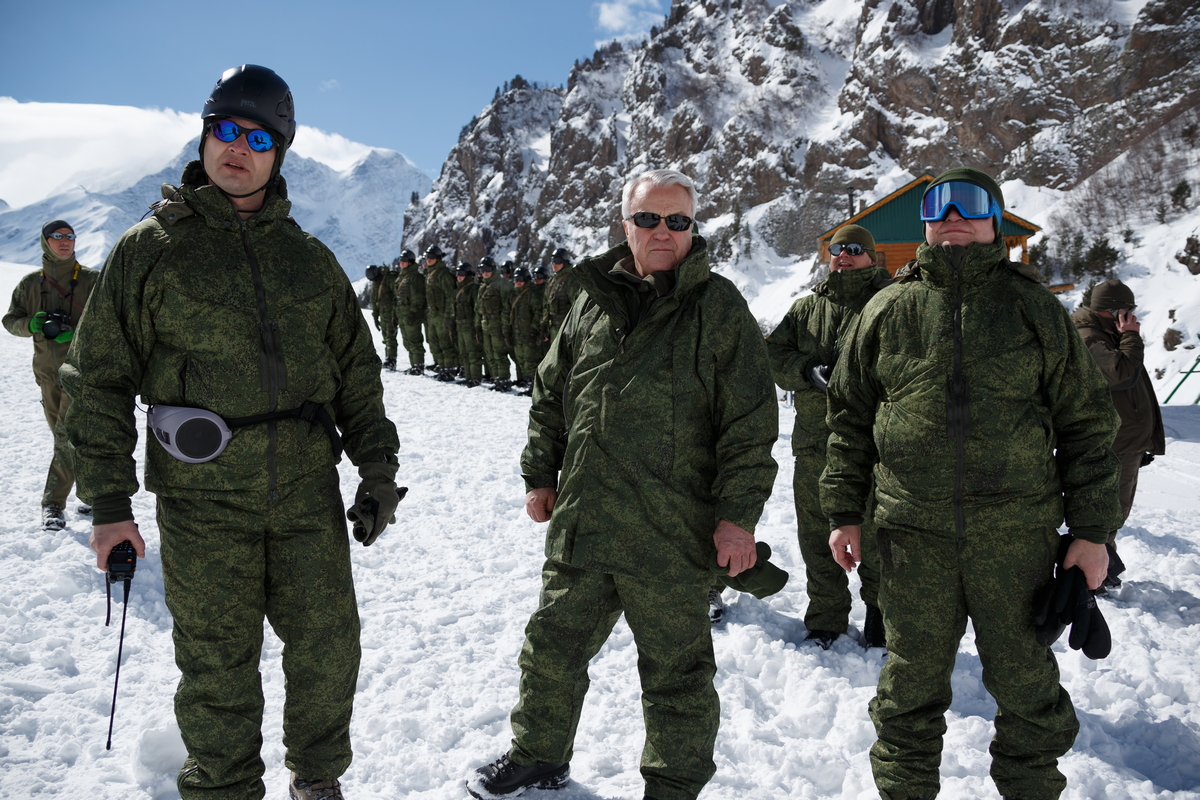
left=406, top=0, right=1200, bottom=271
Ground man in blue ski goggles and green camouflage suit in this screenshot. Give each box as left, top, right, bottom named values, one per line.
left=821, top=168, right=1121, bottom=800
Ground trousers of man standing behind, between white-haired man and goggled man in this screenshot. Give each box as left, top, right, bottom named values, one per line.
left=792, top=449, right=880, bottom=633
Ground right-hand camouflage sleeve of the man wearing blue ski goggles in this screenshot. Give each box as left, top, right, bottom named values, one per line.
left=1033, top=302, right=1122, bottom=543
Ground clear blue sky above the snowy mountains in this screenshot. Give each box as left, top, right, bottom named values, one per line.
left=0, top=0, right=670, bottom=175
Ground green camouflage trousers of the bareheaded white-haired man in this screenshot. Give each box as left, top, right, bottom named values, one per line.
left=510, top=560, right=721, bottom=800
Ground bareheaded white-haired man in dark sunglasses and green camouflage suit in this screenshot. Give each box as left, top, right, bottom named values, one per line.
left=467, top=170, right=779, bottom=800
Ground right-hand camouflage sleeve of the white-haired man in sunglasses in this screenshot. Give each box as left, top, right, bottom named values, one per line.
left=702, top=277, right=779, bottom=533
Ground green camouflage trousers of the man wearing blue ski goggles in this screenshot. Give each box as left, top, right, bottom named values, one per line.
left=870, top=528, right=1079, bottom=800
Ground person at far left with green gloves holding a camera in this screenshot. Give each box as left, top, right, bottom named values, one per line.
left=4, top=219, right=100, bottom=530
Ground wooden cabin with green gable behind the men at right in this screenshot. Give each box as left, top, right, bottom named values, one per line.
left=817, top=173, right=1042, bottom=275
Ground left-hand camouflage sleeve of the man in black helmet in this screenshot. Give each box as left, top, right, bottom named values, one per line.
left=59, top=223, right=160, bottom=513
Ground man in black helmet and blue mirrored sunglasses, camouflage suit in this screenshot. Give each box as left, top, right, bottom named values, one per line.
left=61, top=65, right=400, bottom=800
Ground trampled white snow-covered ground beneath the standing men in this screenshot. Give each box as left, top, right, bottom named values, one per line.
left=0, top=263, right=1200, bottom=800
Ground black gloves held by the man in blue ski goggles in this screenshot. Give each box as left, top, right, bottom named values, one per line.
left=1033, top=534, right=1112, bottom=658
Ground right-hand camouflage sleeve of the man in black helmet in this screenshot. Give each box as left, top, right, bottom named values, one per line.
left=326, top=251, right=400, bottom=465
